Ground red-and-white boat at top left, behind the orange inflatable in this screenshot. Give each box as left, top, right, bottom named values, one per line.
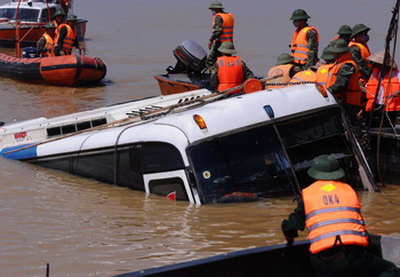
left=0, top=0, right=87, bottom=47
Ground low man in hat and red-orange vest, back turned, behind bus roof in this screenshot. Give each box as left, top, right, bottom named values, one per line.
left=210, top=41, right=254, bottom=94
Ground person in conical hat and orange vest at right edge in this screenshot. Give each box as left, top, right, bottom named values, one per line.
left=365, top=51, right=400, bottom=127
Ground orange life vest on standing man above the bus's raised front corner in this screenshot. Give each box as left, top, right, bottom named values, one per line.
left=291, top=26, right=319, bottom=64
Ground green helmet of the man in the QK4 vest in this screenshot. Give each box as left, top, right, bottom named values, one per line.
left=307, top=155, right=344, bottom=180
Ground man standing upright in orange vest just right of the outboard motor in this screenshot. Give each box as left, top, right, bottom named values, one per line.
left=206, top=1, right=235, bottom=68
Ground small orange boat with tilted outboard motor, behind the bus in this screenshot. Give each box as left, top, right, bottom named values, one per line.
left=154, top=40, right=211, bottom=95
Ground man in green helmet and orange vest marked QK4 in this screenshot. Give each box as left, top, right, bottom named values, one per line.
left=281, top=155, right=398, bottom=277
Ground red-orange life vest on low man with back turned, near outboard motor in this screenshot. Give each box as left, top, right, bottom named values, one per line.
left=217, top=56, right=243, bottom=93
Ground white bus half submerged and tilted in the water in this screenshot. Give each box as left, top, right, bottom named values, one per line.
left=0, top=85, right=378, bottom=204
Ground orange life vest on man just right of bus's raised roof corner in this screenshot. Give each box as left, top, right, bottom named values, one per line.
left=326, top=52, right=362, bottom=106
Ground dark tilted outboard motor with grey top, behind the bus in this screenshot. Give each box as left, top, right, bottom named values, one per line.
left=167, top=40, right=207, bottom=74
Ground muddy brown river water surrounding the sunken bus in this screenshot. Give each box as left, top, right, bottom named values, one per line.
left=0, top=0, right=400, bottom=277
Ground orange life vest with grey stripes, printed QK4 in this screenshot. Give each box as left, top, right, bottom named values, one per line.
left=302, top=181, right=368, bottom=254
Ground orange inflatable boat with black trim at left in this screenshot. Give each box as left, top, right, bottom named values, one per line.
left=0, top=51, right=107, bottom=86
